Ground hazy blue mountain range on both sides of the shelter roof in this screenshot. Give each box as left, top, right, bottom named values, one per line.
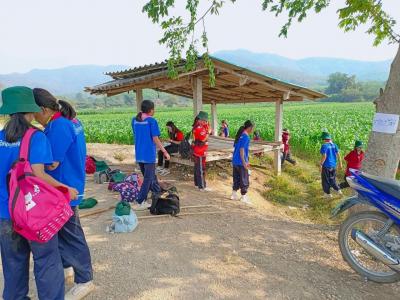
left=0, top=49, right=391, bottom=96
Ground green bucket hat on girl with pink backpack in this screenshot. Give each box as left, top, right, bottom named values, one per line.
left=0, top=86, right=40, bottom=115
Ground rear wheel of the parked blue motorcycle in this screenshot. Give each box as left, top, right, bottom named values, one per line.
left=339, top=211, right=400, bottom=283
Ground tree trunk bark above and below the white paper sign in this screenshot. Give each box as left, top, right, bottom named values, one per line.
left=363, top=46, right=400, bottom=178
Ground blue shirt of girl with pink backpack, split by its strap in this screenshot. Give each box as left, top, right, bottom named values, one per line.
left=0, top=130, right=53, bottom=219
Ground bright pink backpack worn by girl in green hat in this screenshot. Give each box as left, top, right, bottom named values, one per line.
left=8, top=128, right=73, bottom=243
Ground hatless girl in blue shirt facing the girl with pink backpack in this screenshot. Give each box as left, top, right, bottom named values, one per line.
left=33, top=88, right=94, bottom=299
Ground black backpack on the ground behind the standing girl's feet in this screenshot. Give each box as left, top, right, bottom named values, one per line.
left=150, top=187, right=180, bottom=216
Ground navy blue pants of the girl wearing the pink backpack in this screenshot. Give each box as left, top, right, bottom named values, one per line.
left=0, top=219, right=64, bottom=300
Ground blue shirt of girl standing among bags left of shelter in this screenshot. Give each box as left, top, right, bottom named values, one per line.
left=132, top=117, right=160, bottom=164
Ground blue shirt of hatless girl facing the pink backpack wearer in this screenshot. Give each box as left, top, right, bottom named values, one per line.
left=44, top=117, right=86, bottom=206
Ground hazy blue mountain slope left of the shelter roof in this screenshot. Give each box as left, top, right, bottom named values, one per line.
left=0, top=65, right=126, bottom=95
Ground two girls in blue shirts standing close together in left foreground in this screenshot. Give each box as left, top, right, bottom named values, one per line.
left=0, top=86, right=94, bottom=300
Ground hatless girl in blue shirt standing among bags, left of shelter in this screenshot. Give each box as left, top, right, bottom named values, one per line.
left=132, top=100, right=170, bottom=209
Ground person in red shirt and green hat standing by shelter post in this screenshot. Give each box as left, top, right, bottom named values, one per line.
left=192, top=111, right=211, bottom=191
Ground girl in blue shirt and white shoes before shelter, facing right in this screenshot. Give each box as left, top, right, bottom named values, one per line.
left=231, top=120, right=254, bottom=204
